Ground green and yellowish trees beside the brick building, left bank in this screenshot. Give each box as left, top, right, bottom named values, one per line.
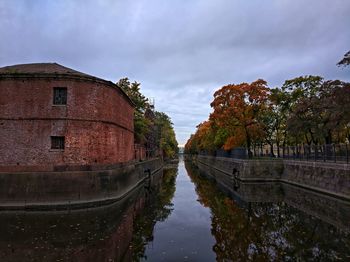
left=116, top=78, right=178, bottom=158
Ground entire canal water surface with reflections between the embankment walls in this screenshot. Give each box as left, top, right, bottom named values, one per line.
left=0, top=159, right=350, bottom=262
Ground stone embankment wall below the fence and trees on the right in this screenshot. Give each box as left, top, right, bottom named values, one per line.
left=194, top=156, right=350, bottom=201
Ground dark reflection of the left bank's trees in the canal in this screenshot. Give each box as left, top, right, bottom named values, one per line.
left=132, top=168, right=177, bottom=261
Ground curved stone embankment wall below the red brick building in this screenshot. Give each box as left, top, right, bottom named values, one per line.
left=0, top=158, right=164, bottom=211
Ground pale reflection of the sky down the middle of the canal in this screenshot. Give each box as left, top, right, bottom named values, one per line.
left=145, top=162, right=215, bottom=261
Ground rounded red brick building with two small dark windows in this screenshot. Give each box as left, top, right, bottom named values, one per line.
left=0, top=63, right=134, bottom=171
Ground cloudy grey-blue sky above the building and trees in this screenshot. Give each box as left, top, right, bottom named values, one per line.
left=0, top=0, right=350, bottom=145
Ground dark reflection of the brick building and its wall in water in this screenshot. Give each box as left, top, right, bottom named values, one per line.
left=0, top=183, right=145, bottom=261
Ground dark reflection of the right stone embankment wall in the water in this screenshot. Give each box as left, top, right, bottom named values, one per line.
left=191, top=160, right=350, bottom=230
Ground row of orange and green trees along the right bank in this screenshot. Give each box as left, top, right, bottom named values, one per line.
left=185, top=52, right=350, bottom=157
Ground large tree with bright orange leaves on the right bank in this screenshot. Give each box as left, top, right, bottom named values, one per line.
left=210, top=79, right=269, bottom=157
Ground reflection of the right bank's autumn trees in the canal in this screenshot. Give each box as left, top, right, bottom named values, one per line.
left=185, top=162, right=350, bottom=261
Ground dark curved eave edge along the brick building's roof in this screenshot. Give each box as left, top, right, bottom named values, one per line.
left=0, top=73, right=135, bottom=107
